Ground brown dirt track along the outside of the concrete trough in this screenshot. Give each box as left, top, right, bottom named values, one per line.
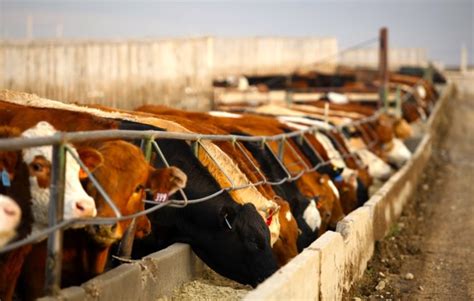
left=344, top=98, right=474, bottom=301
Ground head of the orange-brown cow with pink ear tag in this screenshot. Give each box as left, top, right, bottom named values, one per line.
left=79, top=140, right=186, bottom=246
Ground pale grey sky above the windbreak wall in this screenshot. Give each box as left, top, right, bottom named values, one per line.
left=0, top=0, right=474, bottom=65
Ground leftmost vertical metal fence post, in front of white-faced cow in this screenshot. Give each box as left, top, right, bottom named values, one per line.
left=44, top=144, right=66, bottom=295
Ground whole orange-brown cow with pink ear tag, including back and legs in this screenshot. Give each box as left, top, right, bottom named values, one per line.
left=0, top=100, right=185, bottom=297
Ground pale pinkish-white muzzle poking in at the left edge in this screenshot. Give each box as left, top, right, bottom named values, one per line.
left=0, top=195, right=21, bottom=248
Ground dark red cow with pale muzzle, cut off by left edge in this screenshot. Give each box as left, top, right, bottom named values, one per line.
left=0, top=126, right=33, bottom=301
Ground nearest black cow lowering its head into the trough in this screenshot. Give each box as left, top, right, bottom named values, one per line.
left=120, top=121, right=278, bottom=287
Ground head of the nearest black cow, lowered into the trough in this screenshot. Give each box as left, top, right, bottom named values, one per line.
left=191, top=204, right=278, bottom=287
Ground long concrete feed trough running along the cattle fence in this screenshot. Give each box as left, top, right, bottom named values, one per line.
left=38, top=87, right=460, bottom=300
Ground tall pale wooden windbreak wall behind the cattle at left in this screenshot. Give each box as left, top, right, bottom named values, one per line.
left=0, top=37, right=337, bottom=110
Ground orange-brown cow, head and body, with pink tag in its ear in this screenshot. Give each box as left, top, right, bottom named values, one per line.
left=0, top=102, right=186, bottom=297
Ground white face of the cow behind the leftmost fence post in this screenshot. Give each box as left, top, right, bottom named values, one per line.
left=22, top=121, right=97, bottom=231
